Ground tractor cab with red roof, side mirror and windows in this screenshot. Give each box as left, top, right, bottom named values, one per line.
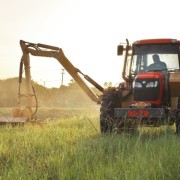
left=118, top=39, right=180, bottom=81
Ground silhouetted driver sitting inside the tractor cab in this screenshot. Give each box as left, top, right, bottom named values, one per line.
left=148, top=54, right=167, bottom=70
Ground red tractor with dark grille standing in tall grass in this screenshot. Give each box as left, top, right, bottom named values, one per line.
left=100, top=39, right=180, bottom=134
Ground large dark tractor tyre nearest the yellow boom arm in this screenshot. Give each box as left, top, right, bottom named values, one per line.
left=100, top=88, right=121, bottom=133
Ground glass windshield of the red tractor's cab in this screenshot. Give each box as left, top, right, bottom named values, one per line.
left=131, top=44, right=180, bottom=76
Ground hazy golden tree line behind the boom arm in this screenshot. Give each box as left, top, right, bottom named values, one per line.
left=0, top=78, right=100, bottom=108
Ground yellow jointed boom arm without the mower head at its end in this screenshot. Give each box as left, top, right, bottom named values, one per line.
left=20, top=40, right=104, bottom=106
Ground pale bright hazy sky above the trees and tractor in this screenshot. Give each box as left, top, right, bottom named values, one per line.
left=0, top=0, right=180, bottom=87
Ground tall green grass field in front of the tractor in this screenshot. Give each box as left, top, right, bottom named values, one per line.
left=0, top=109, right=180, bottom=180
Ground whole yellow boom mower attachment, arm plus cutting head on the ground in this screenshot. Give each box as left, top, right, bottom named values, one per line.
left=0, top=40, right=104, bottom=123
